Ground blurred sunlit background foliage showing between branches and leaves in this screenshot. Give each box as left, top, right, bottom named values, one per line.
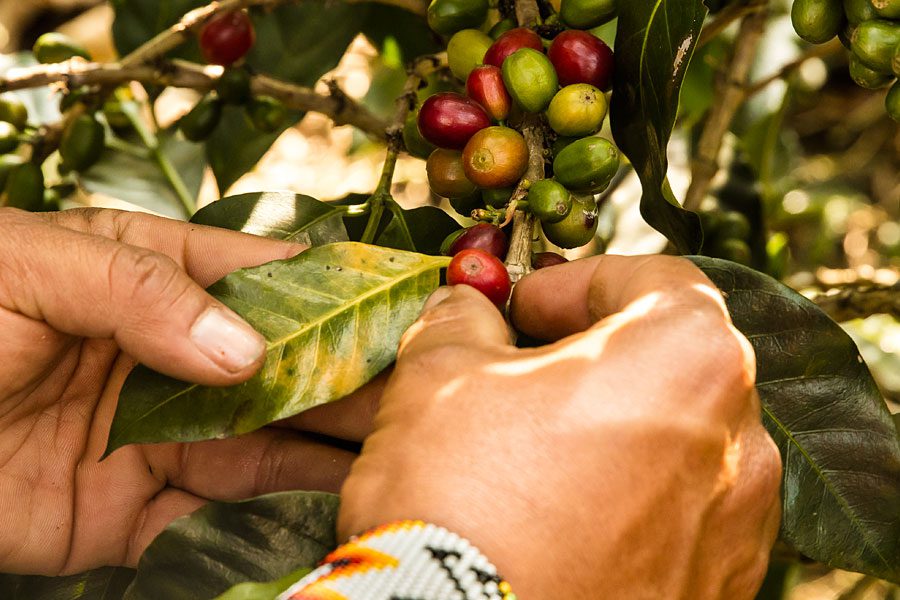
left=0, top=0, right=900, bottom=600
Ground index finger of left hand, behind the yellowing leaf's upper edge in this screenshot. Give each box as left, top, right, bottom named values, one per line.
left=44, top=209, right=306, bottom=287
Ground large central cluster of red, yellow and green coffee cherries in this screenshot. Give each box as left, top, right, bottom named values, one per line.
left=414, top=0, right=619, bottom=304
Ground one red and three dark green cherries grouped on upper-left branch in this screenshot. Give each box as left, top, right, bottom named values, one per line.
left=178, top=11, right=288, bottom=142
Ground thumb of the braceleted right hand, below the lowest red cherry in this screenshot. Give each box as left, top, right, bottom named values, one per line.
left=398, top=285, right=511, bottom=360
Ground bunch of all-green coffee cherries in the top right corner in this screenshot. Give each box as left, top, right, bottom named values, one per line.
left=791, top=0, right=900, bottom=122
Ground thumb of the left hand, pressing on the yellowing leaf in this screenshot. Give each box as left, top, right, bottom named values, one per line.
left=0, top=216, right=266, bottom=385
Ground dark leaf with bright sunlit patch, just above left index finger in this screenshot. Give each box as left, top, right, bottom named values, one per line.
left=191, top=192, right=348, bottom=246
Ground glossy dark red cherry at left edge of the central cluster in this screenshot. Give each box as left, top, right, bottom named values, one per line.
left=419, top=92, right=491, bottom=150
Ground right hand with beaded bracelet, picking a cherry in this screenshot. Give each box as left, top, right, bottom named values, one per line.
left=339, top=256, right=780, bottom=599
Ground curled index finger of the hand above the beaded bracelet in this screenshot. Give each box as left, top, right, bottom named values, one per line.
left=510, top=255, right=729, bottom=341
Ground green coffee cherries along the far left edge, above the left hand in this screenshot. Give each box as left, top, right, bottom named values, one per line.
left=0, top=33, right=106, bottom=212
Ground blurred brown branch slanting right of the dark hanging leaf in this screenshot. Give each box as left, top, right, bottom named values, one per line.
left=684, top=0, right=768, bottom=210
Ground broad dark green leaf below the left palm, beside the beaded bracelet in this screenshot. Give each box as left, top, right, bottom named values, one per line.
left=125, top=492, right=339, bottom=600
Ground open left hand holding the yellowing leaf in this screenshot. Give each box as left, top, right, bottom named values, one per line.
left=0, top=209, right=374, bottom=575
